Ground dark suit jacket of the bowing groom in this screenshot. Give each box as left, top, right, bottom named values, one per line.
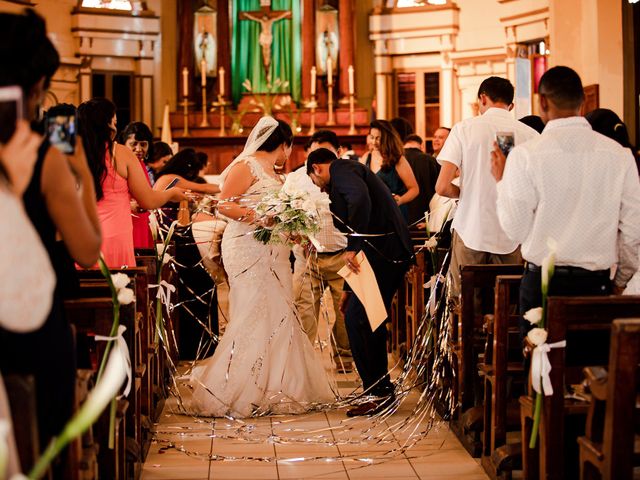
left=328, top=159, right=413, bottom=263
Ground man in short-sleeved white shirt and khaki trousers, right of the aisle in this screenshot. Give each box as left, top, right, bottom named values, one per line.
left=436, top=77, right=538, bottom=295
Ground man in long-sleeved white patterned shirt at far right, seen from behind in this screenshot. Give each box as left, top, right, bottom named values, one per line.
left=492, top=67, right=640, bottom=335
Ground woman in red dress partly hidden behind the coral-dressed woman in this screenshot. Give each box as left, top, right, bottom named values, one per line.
left=120, top=122, right=155, bottom=248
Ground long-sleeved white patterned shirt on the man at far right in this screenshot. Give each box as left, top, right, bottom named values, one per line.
left=498, top=117, right=640, bottom=286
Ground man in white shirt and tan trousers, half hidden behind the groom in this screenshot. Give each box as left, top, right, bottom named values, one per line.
left=289, top=130, right=352, bottom=370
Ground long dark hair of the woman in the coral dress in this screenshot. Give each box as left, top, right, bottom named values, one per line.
left=78, top=98, right=116, bottom=200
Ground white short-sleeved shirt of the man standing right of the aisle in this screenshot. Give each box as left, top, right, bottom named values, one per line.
left=438, top=108, right=538, bottom=254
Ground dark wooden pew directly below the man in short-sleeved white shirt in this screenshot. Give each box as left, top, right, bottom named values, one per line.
left=451, top=264, right=523, bottom=457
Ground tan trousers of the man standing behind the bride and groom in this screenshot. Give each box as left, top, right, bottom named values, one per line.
left=293, top=247, right=351, bottom=357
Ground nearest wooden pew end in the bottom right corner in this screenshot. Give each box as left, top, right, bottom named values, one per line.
left=578, top=318, right=640, bottom=480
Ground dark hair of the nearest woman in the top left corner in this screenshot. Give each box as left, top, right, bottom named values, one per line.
left=0, top=9, right=60, bottom=98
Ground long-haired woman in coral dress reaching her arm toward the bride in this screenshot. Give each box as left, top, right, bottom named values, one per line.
left=78, top=98, right=185, bottom=268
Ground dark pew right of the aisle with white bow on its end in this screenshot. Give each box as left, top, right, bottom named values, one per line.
left=520, top=296, right=640, bottom=480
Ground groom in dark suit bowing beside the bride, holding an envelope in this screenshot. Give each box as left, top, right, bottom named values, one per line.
left=307, top=148, right=413, bottom=416
